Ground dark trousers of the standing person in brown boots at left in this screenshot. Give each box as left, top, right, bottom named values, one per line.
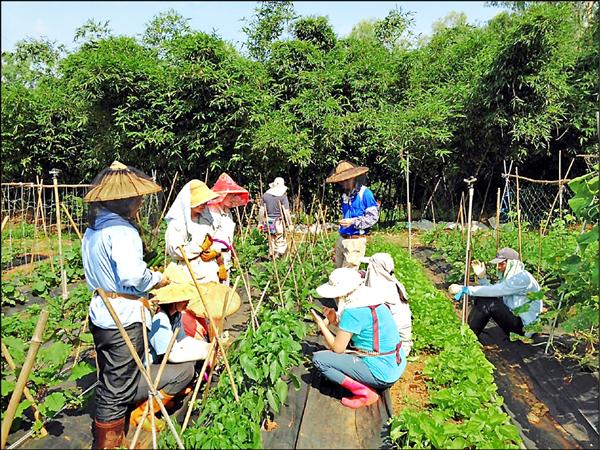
left=89, top=321, right=144, bottom=422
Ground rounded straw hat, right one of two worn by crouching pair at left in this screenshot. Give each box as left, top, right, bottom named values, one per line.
left=187, top=281, right=242, bottom=319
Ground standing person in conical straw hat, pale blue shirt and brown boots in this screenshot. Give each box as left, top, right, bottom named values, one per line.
left=81, top=161, right=169, bottom=448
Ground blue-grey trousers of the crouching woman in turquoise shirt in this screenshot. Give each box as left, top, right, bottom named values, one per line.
left=313, top=350, right=394, bottom=389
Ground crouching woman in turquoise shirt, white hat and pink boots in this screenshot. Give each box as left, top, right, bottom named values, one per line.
left=313, top=268, right=406, bottom=409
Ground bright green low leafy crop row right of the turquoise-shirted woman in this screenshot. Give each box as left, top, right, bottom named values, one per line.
left=369, top=237, right=521, bottom=448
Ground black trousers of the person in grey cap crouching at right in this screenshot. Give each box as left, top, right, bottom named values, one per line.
left=468, top=297, right=523, bottom=335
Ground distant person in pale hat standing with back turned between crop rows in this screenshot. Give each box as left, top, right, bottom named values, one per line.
left=258, top=177, right=292, bottom=258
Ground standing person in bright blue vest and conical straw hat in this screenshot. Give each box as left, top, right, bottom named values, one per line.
left=325, top=161, right=379, bottom=269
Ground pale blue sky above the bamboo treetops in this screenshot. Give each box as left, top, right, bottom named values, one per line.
left=1, top=1, right=502, bottom=51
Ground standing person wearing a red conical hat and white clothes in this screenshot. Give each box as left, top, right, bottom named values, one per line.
left=208, top=173, right=250, bottom=284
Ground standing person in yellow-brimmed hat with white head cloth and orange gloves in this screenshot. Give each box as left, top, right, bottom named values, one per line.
left=165, top=180, right=226, bottom=283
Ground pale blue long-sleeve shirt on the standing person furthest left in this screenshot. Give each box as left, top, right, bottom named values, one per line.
left=81, top=209, right=162, bottom=329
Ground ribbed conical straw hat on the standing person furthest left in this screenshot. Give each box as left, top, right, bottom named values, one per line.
left=84, top=161, right=162, bottom=202
